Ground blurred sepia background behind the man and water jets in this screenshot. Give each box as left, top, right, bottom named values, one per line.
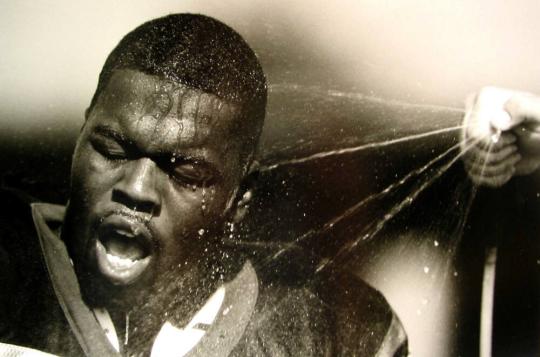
left=0, top=0, right=540, bottom=356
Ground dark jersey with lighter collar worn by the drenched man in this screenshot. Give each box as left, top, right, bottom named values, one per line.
left=0, top=191, right=407, bottom=356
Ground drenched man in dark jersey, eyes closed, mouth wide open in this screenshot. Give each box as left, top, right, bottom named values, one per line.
left=0, top=14, right=407, bottom=356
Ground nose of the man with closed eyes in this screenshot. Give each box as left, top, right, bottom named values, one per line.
left=112, top=158, right=161, bottom=215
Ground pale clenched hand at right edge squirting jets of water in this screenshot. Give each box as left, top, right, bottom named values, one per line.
left=461, top=87, right=540, bottom=187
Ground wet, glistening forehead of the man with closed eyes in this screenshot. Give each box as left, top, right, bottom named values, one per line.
left=90, top=70, right=242, bottom=153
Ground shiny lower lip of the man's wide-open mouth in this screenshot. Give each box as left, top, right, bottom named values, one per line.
left=96, top=240, right=152, bottom=285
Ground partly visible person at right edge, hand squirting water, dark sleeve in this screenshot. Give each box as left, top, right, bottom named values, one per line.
left=459, top=87, right=540, bottom=356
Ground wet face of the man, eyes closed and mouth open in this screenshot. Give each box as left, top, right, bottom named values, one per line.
left=64, top=70, right=245, bottom=302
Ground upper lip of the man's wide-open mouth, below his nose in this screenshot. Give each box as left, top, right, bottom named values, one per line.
left=98, top=211, right=156, bottom=255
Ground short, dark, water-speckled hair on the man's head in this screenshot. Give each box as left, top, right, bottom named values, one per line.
left=87, top=14, right=267, bottom=161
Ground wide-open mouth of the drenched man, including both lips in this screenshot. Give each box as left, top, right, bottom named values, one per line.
left=96, top=214, right=153, bottom=285
